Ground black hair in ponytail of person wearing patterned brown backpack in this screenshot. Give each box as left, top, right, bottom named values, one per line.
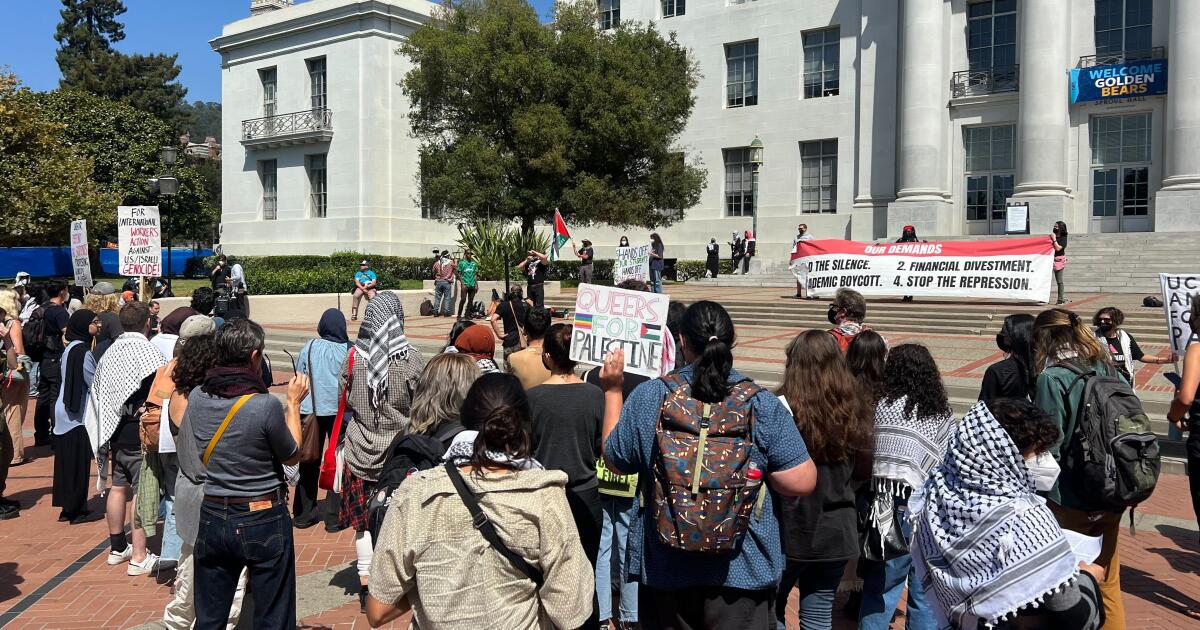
left=679, top=300, right=734, bottom=403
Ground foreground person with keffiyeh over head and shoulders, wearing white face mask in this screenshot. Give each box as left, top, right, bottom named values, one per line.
left=908, top=398, right=1105, bottom=630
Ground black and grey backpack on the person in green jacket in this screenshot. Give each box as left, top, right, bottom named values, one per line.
left=1057, top=361, right=1163, bottom=520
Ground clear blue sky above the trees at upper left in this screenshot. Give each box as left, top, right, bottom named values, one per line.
left=0, top=0, right=553, bottom=101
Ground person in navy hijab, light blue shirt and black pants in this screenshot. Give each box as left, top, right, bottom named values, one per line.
left=292, top=308, right=350, bottom=532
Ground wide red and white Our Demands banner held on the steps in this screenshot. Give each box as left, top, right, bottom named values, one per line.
left=792, top=236, right=1054, bottom=302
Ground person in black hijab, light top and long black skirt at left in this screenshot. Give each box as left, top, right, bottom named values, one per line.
left=50, top=308, right=100, bottom=524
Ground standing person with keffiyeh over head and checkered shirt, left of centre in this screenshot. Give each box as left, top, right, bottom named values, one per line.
left=338, top=292, right=427, bottom=610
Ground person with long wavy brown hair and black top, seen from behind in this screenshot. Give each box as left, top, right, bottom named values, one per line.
left=775, top=330, right=875, bottom=630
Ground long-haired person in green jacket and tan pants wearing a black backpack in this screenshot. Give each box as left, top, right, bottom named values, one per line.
left=1033, top=308, right=1124, bottom=630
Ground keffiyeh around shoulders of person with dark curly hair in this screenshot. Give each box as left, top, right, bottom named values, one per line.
left=874, top=396, right=954, bottom=494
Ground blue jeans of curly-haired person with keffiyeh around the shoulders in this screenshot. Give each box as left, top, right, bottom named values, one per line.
left=858, top=497, right=937, bottom=630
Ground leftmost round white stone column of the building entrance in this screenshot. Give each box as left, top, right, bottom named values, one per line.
left=887, top=0, right=959, bottom=236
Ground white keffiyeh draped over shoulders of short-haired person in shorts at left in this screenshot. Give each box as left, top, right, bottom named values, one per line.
left=84, top=332, right=167, bottom=452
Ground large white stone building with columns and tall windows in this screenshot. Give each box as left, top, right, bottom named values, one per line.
left=214, top=0, right=1200, bottom=259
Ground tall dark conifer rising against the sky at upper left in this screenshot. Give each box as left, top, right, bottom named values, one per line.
left=54, top=0, right=188, bottom=131
